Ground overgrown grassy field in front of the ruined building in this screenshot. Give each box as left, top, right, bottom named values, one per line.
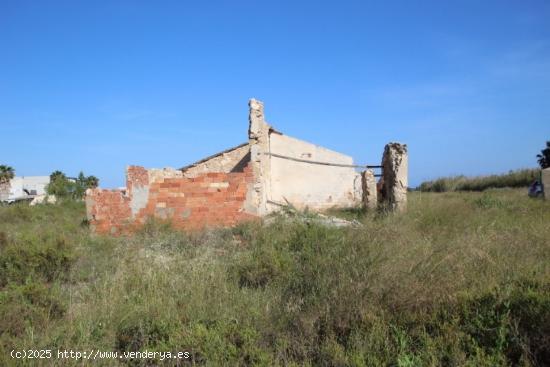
left=0, top=189, right=550, bottom=366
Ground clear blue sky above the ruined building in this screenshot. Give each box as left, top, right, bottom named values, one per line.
left=0, top=0, right=550, bottom=187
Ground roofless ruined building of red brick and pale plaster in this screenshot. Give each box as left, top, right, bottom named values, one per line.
left=86, top=99, right=407, bottom=234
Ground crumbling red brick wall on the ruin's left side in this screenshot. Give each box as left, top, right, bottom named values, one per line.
left=87, top=166, right=254, bottom=234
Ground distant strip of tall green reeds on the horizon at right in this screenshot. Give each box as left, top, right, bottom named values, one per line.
left=418, top=168, right=540, bottom=192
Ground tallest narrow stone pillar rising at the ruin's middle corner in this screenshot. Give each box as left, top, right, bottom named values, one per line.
left=245, top=98, right=270, bottom=216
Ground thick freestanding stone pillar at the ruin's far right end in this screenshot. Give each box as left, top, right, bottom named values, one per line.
left=382, top=143, right=408, bottom=212
